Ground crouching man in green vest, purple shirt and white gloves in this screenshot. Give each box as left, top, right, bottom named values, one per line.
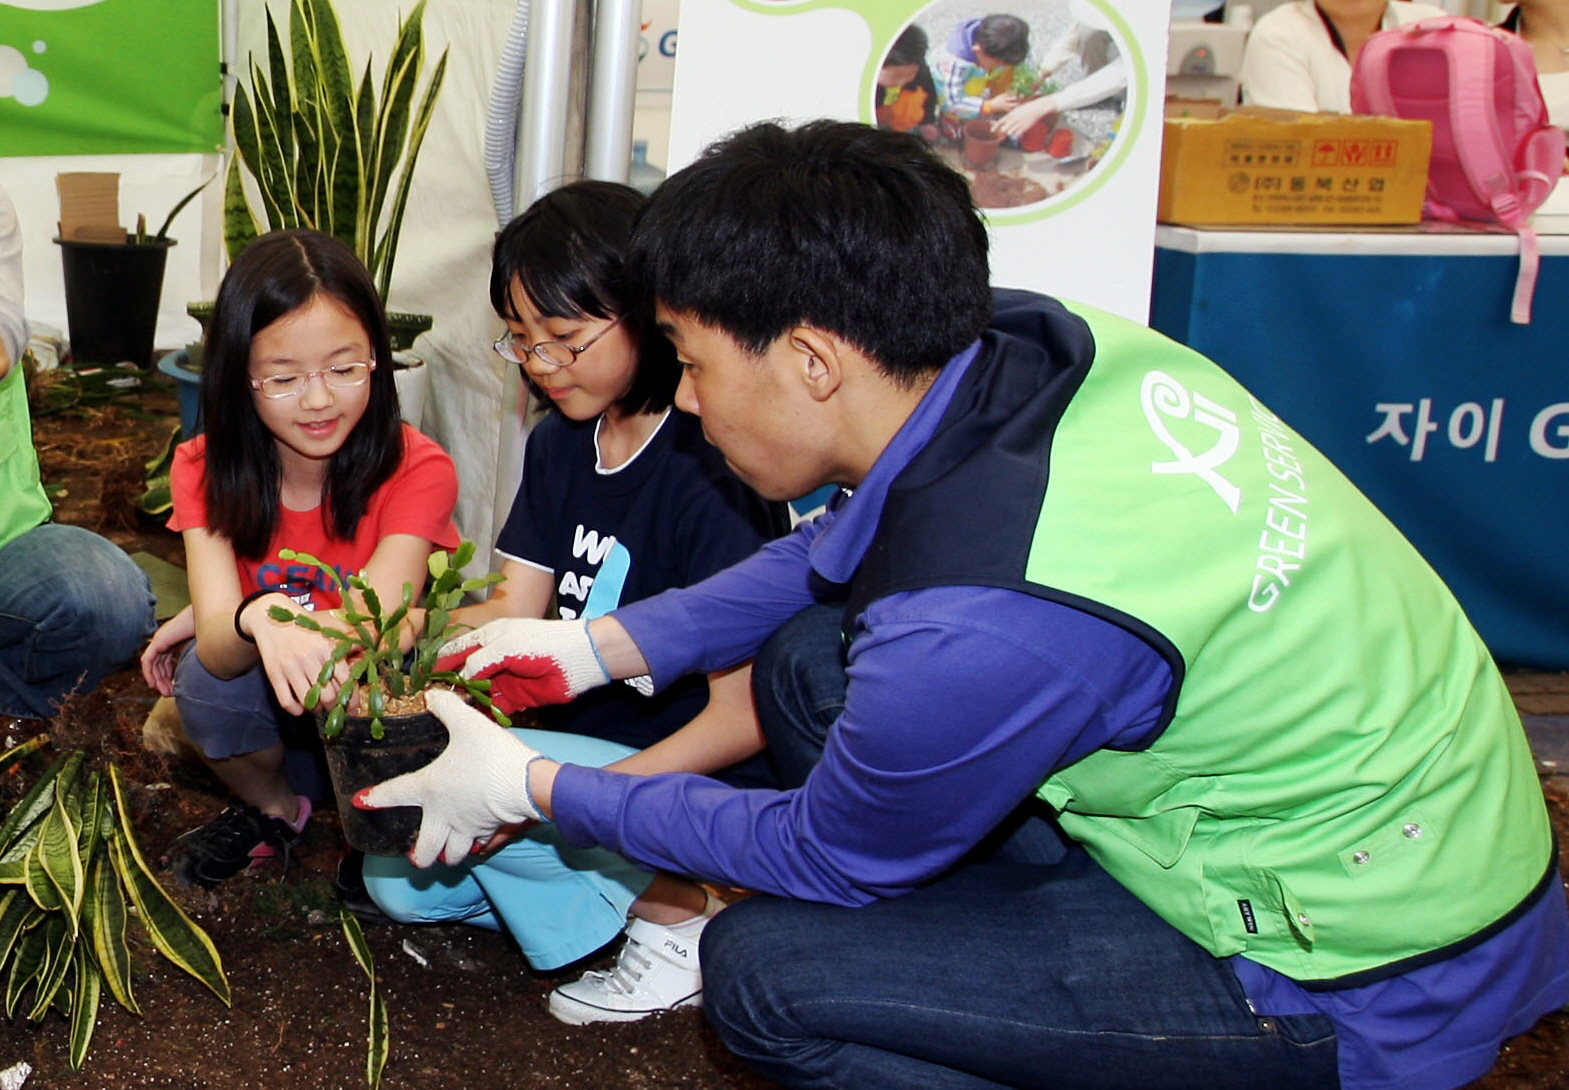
left=361, top=122, right=1569, bottom=1090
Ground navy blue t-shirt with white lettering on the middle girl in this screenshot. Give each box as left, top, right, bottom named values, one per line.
left=496, top=409, right=789, bottom=786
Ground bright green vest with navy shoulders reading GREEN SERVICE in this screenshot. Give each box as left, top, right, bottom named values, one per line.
left=852, top=295, right=1555, bottom=986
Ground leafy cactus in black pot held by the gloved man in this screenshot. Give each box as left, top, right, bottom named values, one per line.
left=268, top=541, right=510, bottom=855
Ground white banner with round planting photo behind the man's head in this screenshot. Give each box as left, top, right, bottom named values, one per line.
left=670, top=0, right=1169, bottom=322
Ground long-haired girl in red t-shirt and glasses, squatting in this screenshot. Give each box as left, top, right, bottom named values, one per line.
left=141, top=231, right=458, bottom=886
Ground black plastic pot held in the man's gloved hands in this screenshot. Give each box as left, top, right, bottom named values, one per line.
left=315, top=712, right=447, bottom=855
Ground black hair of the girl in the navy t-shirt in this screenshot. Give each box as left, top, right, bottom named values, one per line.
left=491, top=180, right=668, bottom=412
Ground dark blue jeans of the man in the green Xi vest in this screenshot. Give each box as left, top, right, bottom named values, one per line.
left=701, top=607, right=1338, bottom=1090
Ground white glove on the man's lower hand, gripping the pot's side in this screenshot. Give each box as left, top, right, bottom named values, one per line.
left=355, top=689, right=546, bottom=867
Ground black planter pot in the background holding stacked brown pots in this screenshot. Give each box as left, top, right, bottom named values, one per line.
left=55, top=235, right=174, bottom=367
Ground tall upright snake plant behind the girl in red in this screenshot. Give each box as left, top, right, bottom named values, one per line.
left=224, top=0, right=447, bottom=300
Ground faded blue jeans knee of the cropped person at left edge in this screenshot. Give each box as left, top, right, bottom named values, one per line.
left=0, top=522, right=154, bottom=718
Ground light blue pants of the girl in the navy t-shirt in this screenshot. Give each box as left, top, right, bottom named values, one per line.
left=364, top=729, right=654, bottom=969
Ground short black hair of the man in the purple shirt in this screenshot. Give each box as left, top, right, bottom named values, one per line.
left=628, top=121, right=992, bottom=383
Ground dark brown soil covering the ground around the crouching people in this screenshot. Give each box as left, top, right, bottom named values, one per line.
left=9, top=373, right=1569, bottom=1090
